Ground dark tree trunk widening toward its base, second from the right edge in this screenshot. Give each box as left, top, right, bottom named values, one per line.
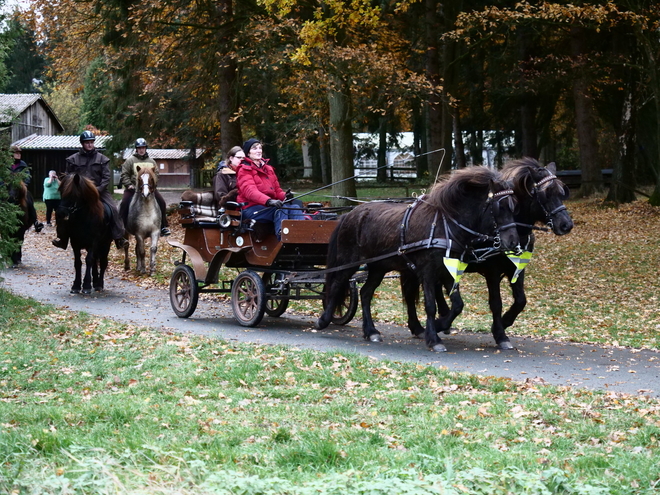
left=605, top=86, right=635, bottom=204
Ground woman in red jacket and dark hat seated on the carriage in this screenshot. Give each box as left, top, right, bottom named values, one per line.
left=236, top=139, right=305, bottom=239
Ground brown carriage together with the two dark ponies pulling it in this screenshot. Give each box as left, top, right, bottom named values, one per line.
left=170, top=158, right=573, bottom=352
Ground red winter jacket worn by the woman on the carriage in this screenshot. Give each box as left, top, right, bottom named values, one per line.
left=236, top=158, right=286, bottom=208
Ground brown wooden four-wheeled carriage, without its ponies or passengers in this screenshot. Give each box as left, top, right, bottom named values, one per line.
left=168, top=201, right=358, bottom=327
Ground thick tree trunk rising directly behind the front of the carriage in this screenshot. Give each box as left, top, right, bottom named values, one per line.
left=328, top=76, right=357, bottom=206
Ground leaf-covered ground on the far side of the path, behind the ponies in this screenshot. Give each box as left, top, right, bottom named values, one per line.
left=105, top=199, right=660, bottom=349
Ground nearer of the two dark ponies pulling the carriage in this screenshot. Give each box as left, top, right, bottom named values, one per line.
left=317, top=167, right=518, bottom=352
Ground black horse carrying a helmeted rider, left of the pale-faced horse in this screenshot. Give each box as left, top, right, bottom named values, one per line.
left=55, top=174, right=112, bottom=294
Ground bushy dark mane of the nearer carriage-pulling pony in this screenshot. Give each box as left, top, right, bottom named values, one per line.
left=427, top=166, right=502, bottom=216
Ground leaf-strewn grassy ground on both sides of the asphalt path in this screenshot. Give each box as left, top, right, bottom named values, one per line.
left=0, top=200, right=660, bottom=495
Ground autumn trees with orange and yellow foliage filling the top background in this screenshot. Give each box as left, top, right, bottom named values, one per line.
left=15, top=0, right=660, bottom=203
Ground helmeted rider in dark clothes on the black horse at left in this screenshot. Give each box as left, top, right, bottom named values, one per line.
left=53, top=131, right=126, bottom=249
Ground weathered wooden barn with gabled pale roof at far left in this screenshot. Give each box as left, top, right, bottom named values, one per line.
left=0, top=94, right=64, bottom=143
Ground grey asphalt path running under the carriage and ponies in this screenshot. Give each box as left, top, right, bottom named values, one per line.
left=0, top=190, right=660, bottom=397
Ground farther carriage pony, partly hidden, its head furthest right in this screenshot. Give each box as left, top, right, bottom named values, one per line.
left=401, top=158, right=573, bottom=350
